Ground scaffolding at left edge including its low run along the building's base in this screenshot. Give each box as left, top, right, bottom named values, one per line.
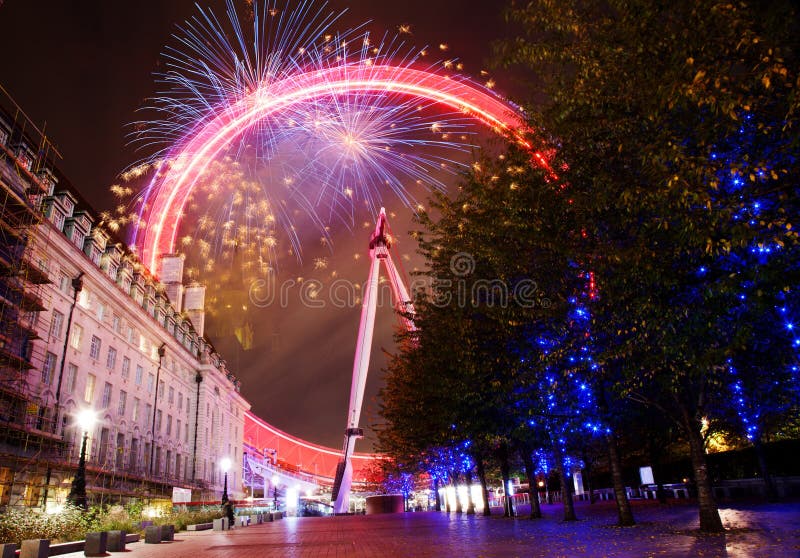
left=0, top=86, right=213, bottom=511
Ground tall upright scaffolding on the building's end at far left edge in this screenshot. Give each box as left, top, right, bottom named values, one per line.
left=0, top=87, right=66, bottom=507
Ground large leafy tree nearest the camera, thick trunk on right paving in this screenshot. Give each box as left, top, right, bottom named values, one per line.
left=497, top=0, right=798, bottom=531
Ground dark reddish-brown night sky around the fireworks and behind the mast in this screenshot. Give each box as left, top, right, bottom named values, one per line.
left=0, top=0, right=520, bottom=450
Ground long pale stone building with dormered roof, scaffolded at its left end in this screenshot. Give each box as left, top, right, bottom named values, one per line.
left=0, top=95, right=250, bottom=508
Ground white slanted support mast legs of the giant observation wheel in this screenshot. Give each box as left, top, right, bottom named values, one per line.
left=333, top=208, right=414, bottom=514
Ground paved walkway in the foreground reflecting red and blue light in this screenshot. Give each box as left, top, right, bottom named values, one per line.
left=59, top=502, right=800, bottom=558
